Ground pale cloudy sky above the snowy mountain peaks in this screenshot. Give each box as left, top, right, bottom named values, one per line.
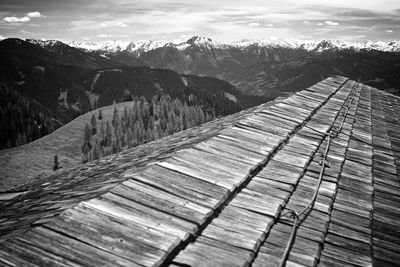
left=0, top=0, right=400, bottom=41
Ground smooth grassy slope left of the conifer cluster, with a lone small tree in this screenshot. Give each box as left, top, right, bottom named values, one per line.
left=0, top=102, right=133, bottom=191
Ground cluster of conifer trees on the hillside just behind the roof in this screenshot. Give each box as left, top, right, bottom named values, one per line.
left=81, top=94, right=216, bottom=162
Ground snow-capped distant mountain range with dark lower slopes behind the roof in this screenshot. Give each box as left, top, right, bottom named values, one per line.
left=61, top=36, right=400, bottom=99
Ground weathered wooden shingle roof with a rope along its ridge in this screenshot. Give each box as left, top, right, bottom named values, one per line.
left=0, top=77, right=400, bottom=266
